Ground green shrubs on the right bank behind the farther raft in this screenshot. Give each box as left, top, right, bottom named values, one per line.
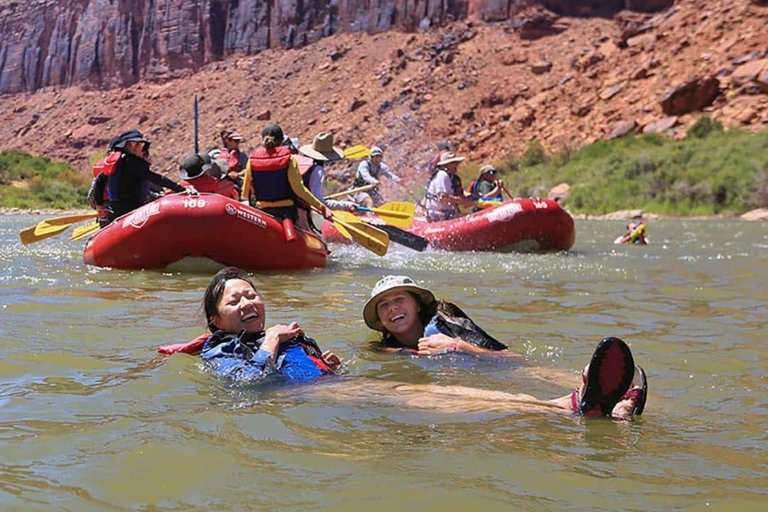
left=474, top=117, right=768, bottom=215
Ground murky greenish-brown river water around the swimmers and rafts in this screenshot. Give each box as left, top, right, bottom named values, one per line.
left=0, top=216, right=768, bottom=511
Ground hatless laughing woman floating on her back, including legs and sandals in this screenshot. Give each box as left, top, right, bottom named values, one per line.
left=158, top=267, right=647, bottom=420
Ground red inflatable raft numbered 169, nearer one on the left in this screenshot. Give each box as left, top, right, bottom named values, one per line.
left=83, top=194, right=328, bottom=270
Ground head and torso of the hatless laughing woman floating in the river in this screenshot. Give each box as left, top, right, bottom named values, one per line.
left=200, top=267, right=343, bottom=381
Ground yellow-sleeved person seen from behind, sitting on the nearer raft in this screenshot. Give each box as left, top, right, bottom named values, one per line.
left=246, top=124, right=332, bottom=223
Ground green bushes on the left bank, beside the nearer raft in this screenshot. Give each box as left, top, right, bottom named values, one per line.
left=0, top=151, right=91, bottom=209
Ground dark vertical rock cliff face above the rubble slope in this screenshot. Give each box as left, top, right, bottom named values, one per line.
left=0, top=0, right=672, bottom=94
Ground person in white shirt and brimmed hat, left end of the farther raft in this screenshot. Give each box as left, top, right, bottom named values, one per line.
left=424, top=152, right=474, bottom=222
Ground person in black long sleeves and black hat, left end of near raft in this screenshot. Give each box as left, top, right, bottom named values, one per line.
left=107, top=130, right=195, bottom=222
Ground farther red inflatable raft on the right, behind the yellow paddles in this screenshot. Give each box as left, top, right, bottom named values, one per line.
left=323, top=199, right=576, bottom=251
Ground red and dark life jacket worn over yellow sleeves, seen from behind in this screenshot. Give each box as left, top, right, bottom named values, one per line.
left=250, top=146, right=295, bottom=201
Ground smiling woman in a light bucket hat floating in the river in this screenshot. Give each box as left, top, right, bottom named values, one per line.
left=363, top=276, right=525, bottom=361
